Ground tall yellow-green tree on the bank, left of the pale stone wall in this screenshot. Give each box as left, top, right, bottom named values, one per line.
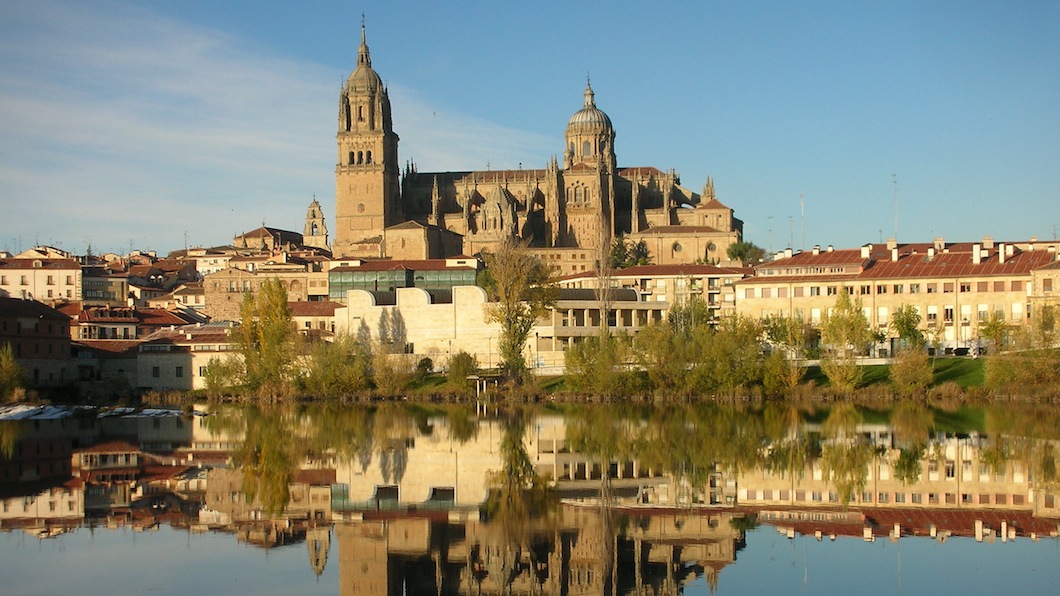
left=235, top=278, right=295, bottom=397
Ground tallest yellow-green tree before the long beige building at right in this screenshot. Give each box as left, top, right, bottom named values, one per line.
left=820, top=287, right=872, bottom=392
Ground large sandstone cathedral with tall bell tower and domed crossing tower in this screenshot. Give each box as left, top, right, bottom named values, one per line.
left=333, top=25, right=743, bottom=273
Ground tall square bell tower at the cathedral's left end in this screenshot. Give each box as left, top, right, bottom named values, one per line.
left=334, top=22, right=402, bottom=257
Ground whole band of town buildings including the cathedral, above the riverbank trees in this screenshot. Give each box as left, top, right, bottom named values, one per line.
left=0, top=25, right=1060, bottom=395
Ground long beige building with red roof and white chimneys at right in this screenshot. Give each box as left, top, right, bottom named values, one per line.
left=736, top=238, right=1057, bottom=350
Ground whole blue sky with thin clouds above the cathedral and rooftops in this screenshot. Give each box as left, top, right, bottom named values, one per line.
left=0, top=0, right=1060, bottom=252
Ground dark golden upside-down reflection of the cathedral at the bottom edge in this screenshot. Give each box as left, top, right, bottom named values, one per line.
left=336, top=506, right=744, bottom=596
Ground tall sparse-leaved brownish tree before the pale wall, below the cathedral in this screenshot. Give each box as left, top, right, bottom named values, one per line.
left=483, top=238, right=557, bottom=383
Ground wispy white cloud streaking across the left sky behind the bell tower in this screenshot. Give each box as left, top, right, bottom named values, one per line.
left=0, top=2, right=562, bottom=251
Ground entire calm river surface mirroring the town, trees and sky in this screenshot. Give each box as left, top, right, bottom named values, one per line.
left=0, top=398, right=1060, bottom=595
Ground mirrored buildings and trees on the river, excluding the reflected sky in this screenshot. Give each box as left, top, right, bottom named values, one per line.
left=0, top=403, right=1060, bottom=594
